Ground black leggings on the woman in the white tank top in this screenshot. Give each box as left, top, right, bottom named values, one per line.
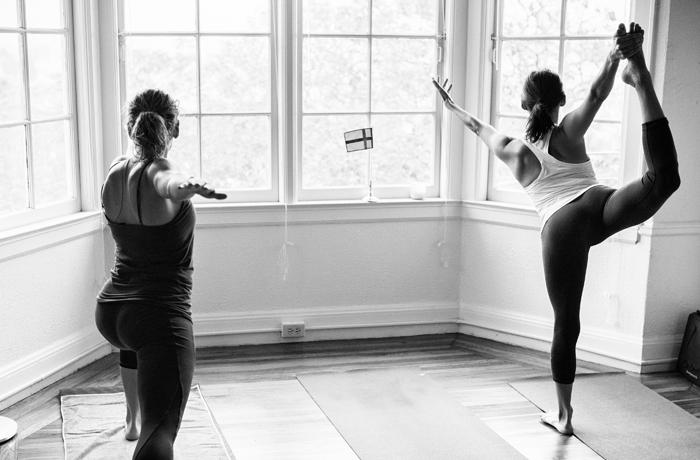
left=542, top=118, right=680, bottom=384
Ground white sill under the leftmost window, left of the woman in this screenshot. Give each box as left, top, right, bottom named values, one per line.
left=0, top=211, right=102, bottom=262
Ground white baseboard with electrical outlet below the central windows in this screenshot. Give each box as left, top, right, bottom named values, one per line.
left=194, top=302, right=459, bottom=347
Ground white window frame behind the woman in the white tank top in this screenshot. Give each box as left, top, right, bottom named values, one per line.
left=478, top=0, right=655, bottom=206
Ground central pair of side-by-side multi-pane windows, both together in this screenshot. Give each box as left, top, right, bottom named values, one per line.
left=118, top=0, right=444, bottom=201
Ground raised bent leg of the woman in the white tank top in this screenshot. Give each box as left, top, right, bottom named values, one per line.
left=603, top=44, right=680, bottom=237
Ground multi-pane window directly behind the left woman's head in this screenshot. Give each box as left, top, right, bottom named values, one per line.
left=119, top=0, right=278, bottom=201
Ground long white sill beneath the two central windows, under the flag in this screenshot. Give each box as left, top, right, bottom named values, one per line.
left=196, top=198, right=461, bottom=228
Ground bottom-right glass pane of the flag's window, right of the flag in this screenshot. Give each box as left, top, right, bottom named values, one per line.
left=372, top=115, right=435, bottom=185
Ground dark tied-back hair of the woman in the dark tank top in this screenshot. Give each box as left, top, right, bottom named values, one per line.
left=126, top=89, right=178, bottom=161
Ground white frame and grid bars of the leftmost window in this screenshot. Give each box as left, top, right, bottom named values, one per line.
left=0, top=0, right=82, bottom=231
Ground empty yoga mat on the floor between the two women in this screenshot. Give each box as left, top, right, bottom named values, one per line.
left=297, top=369, right=525, bottom=460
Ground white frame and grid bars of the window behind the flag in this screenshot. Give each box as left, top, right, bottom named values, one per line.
left=287, top=0, right=450, bottom=202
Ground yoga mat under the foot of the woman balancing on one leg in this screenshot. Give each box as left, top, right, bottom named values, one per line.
left=510, top=374, right=700, bottom=460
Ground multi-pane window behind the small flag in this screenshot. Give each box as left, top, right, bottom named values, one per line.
left=296, top=0, right=443, bottom=199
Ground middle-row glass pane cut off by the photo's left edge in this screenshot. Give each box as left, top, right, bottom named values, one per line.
left=0, top=34, right=25, bottom=123
